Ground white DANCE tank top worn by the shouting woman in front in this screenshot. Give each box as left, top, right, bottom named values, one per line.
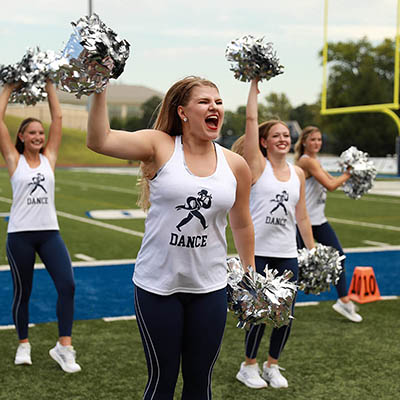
left=133, top=136, right=237, bottom=295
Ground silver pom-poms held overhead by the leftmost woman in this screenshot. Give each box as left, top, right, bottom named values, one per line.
left=0, top=47, right=65, bottom=105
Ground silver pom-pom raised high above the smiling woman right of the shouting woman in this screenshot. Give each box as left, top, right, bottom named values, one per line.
left=225, top=35, right=284, bottom=82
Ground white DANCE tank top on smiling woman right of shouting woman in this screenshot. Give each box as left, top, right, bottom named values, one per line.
left=250, top=159, right=300, bottom=258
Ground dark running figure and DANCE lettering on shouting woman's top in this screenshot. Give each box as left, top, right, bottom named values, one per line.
left=169, top=189, right=212, bottom=248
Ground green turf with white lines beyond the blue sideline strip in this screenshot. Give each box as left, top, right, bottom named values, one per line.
left=0, top=169, right=400, bottom=265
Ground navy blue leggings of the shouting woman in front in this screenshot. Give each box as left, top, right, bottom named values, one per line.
left=135, top=287, right=227, bottom=400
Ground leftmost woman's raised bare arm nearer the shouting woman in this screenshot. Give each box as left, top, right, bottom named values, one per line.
left=43, top=81, right=62, bottom=170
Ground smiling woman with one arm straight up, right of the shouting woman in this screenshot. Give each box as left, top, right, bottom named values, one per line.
left=232, top=80, right=314, bottom=388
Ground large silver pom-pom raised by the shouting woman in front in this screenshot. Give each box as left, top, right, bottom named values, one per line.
left=60, top=14, right=130, bottom=98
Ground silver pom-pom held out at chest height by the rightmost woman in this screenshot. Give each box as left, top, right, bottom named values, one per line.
left=339, top=146, right=377, bottom=199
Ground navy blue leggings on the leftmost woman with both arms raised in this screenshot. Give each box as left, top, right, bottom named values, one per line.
left=6, top=231, right=75, bottom=340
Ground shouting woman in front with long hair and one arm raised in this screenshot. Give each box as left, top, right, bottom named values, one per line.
left=87, top=77, right=254, bottom=400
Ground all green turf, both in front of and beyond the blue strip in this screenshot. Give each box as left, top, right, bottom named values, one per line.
left=0, top=169, right=400, bottom=400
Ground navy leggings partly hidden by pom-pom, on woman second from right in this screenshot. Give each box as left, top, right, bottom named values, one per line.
left=245, top=256, right=298, bottom=360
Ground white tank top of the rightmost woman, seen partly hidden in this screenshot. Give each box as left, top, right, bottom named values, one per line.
left=301, top=154, right=327, bottom=225
